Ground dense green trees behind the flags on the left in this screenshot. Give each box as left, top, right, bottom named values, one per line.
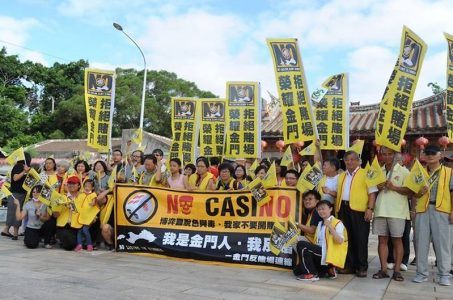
left=0, top=48, right=216, bottom=150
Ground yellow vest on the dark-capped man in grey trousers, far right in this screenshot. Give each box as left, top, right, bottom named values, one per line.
left=415, top=166, right=452, bottom=213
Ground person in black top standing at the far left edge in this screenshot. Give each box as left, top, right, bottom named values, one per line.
left=1, top=152, right=31, bottom=240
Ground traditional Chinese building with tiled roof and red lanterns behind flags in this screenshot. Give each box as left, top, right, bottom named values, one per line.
left=261, top=92, right=453, bottom=161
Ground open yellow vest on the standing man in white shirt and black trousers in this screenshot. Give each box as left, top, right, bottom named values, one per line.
left=335, top=168, right=368, bottom=213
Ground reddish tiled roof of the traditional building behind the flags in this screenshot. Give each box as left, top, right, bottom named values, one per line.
left=262, top=93, right=447, bottom=138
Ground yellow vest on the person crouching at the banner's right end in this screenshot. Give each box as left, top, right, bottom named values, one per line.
left=315, top=217, right=348, bottom=269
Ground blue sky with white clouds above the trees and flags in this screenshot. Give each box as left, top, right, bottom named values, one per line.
left=0, top=0, right=453, bottom=104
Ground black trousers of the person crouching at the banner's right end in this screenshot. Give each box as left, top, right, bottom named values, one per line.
left=293, top=241, right=322, bottom=276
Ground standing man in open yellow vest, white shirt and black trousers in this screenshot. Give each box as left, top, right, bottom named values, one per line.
left=335, top=151, right=378, bottom=277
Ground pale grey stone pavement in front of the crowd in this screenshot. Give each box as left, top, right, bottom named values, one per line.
left=0, top=232, right=453, bottom=300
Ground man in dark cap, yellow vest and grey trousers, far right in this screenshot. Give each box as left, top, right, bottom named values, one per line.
left=412, top=145, right=453, bottom=286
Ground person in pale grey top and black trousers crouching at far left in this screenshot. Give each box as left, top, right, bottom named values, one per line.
left=14, top=185, right=49, bottom=249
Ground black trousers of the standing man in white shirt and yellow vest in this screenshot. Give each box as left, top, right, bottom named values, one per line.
left=338, top=201, right=370, bottom=271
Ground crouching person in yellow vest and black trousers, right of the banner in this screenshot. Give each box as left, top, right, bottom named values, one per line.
left=296, top=200, right=348, bottom=281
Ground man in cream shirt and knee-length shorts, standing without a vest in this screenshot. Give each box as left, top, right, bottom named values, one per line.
left=373, top=147, right=411, bottom=281
